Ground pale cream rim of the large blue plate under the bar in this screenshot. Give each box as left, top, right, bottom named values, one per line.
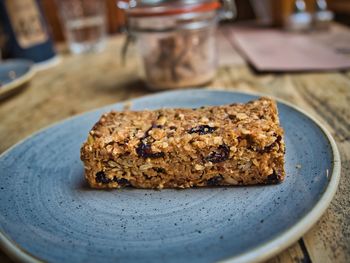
left=0, top=88, right=341, bottom=263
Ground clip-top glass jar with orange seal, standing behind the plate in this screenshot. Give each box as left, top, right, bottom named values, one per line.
left=118, top=0, right=235, bottom=89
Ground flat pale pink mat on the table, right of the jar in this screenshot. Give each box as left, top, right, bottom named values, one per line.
left=226, top=26, right=350, bottom=71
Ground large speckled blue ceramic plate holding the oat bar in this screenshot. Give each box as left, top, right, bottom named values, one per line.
left=0, top=90, right=340, bottom=262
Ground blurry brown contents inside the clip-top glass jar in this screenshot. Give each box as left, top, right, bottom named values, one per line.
left=139, top=27, right=216, bottom=88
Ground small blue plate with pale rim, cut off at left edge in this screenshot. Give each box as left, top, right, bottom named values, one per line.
left=0, top=59, right=34, bottom=98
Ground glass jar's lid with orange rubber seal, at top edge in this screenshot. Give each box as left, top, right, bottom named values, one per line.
left=118, top=0, right=221, bottom=17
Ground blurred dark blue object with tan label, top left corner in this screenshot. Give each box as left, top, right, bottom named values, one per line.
left=0, top=0, right=55, bottom=63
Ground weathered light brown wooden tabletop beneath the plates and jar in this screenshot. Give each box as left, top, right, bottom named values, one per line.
left=0, top=27, right=350, bottom=263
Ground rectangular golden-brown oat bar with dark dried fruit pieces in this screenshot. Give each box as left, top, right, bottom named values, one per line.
left=81, top=98, right=285, bottom=188
